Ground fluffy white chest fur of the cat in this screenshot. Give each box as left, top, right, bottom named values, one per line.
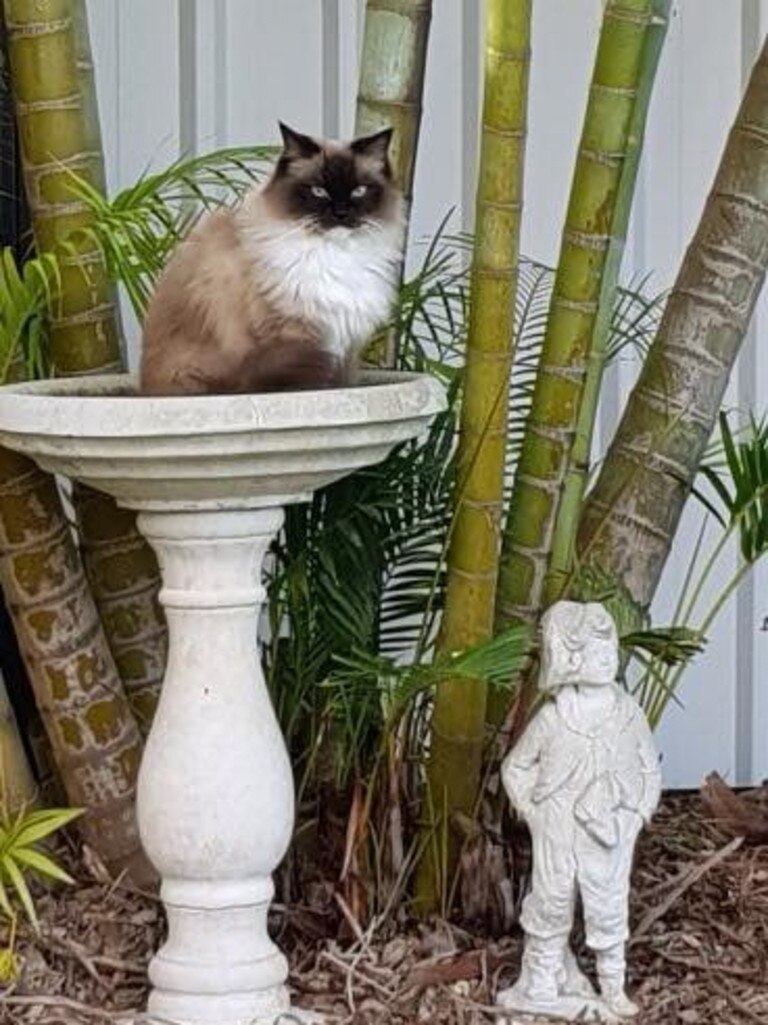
left=243, top=214, right=403, bottom=357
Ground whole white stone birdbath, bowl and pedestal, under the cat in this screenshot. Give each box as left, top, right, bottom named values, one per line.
left=0, top=372, right=445, bottom=1025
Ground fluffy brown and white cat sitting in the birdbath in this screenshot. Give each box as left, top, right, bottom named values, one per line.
left=139, top=124, right=404, bottom=395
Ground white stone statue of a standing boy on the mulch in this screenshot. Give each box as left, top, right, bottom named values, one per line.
left=497, top=602, right=661, bottom=1022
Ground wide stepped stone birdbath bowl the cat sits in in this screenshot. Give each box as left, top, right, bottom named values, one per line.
left=0, top=371, right=446, bottom=511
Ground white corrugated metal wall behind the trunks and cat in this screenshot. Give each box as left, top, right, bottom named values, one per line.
left=88, top=0, right=768, bottom=786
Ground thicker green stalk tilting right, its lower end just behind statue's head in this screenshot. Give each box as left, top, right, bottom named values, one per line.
left=496, top=0, right=654, bottom=627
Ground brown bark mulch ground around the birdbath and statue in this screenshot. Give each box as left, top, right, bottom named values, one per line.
left=0, top=791, right=768, bottom=1025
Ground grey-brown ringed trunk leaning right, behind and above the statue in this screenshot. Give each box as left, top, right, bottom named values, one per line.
left=578, top=42, right=768, bottom=607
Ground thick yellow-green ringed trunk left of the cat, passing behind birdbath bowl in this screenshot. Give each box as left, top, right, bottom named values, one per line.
left=5, top=0, right=166, bottom=732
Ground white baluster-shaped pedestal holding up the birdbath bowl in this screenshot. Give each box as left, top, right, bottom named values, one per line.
left=137, top=507, right=315, bottom=1025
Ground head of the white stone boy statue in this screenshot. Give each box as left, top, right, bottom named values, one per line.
left=539, top=602, right=618, bottom=691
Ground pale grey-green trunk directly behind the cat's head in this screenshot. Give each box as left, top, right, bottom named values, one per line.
left=355, top=0, right=432, bottom=367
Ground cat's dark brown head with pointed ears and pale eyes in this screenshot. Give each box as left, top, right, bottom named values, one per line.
left=265, top=123, right=399, bottom=231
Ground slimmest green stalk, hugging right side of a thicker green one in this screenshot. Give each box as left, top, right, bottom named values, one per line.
left=544, top=0, right=672, bottom=606
